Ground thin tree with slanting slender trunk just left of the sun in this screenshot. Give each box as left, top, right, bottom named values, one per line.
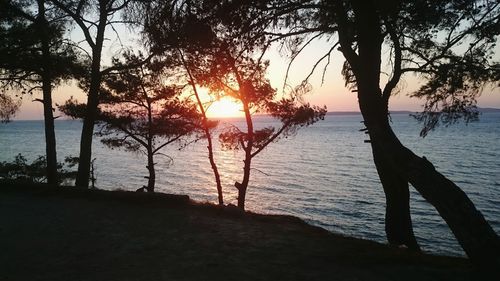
left=130, top=1, right=224, bottom=205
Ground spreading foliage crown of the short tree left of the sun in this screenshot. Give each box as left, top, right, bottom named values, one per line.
left=98, top=55, right=201, bottom=153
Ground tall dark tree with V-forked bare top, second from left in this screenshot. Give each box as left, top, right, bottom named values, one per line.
left=49, top=0, right=143, bottom=187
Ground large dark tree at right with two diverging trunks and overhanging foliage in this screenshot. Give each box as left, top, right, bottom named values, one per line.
left=235, top=0, right=500, bottom=264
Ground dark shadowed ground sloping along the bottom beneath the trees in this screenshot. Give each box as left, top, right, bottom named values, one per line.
left=0, top=183, right=484, bottom=281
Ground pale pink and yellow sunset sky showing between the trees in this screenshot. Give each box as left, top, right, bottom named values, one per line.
left=14, top=24, right=500, bottom=120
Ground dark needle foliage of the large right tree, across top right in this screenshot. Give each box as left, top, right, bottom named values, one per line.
left=218, top=0, right=500, bottom=136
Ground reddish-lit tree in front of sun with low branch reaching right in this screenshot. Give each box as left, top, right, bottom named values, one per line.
left=139, top=0, right=326, bottom=209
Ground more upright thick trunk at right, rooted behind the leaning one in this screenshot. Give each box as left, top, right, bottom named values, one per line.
left=342, top=0, right=419, bottom=250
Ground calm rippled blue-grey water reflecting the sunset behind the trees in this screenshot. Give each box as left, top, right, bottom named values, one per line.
left=0, top=113, right=500, bottom=255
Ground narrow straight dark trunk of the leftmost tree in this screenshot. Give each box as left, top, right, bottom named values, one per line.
left=37, top=0, right=59, bottom=185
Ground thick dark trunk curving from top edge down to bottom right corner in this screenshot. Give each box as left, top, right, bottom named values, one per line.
left=350, top=0, right=500, bottom=264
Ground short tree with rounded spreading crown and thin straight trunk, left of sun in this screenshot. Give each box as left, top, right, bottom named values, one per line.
left=61, top=54, right=201, bottom=192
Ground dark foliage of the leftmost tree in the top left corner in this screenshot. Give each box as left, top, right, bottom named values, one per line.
left=0, top=0, right=83, bottom=94
